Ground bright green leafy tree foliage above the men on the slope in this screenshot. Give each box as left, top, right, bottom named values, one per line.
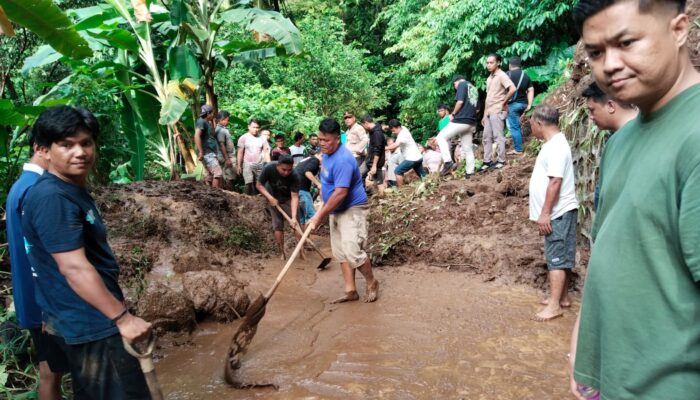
left=379, top=0, right=576, bottom=136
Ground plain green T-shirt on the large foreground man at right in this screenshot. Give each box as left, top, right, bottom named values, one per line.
left=574, top=84, right=700, bottom=400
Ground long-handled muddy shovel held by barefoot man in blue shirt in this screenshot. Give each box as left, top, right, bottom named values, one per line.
left=224, top=226, right=311, bottom=388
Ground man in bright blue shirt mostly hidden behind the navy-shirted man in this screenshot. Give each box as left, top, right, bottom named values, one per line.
left=5, top=135, right=68, bottom=400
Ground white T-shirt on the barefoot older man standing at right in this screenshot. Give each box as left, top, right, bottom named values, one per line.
left=530, top=133, right=578, bottom=221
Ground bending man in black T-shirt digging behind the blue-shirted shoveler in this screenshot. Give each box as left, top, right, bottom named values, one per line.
left=255, top=154, right=304, bottom=261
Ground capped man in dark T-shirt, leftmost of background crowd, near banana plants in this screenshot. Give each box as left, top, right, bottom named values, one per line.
left=194, top=104, right=224, bottom=188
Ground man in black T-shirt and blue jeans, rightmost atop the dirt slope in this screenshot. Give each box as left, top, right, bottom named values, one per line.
left=506, top=57, right=535, bottom=155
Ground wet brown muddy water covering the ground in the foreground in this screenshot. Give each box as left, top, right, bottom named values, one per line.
left=156, top=253, right=578, bottom=400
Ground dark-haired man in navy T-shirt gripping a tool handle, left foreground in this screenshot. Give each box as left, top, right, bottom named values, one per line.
left=22, top=106, right=151, bottom=399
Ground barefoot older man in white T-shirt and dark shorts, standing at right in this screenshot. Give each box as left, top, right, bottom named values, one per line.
left=530, top=105, right=578, bottom=322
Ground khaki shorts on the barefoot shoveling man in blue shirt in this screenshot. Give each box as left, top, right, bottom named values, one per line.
left=330, top=204, right=369, bottom=268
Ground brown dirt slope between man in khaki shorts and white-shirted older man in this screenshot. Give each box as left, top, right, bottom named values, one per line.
left=369, top=158, right=588, bottom=287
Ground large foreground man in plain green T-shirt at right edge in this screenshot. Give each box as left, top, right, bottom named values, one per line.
left=570, top=0, right=700, bottom=400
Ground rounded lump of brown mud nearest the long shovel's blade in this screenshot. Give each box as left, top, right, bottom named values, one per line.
left=183, top=271, right=250, bottom=321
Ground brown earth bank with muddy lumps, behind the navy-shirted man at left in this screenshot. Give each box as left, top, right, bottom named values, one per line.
left=94, top=181, right=273, bottom=331
